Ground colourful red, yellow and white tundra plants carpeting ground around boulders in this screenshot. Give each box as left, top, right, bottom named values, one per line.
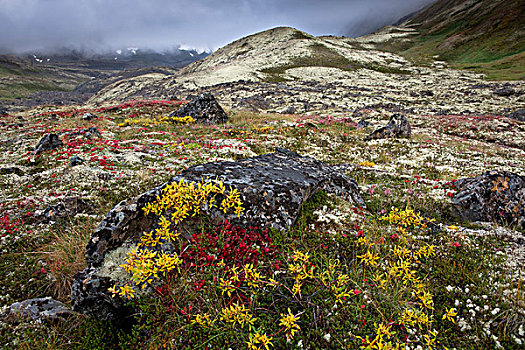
left=0, top=97, right=525, bottom=350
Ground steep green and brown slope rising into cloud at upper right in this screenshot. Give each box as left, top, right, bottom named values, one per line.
left=370, top=0, right=525, bottom=80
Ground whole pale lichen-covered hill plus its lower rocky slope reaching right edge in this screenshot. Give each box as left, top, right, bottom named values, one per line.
left=89, top=27, right=525, bottom=119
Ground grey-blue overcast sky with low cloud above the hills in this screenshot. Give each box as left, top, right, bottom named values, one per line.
left=0, top=0, right=433, bottom=52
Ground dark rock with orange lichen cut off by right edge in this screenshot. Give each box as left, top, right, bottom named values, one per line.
left=452, top=171, right=525, bottom=229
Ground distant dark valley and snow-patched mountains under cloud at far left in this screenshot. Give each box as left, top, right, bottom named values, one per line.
left=0, top=47, right=209, bottom=106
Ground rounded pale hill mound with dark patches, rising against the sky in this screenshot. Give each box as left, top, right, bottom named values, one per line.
left=91, top=27, right=409, bottom=103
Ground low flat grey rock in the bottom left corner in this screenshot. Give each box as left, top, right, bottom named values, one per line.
left=6, top=297, right=76, bottom=321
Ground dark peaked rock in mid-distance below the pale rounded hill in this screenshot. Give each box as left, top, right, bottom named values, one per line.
left=170, top=94, right=228, bottom=124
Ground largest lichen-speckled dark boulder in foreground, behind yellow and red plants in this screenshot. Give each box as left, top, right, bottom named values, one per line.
left=71, top=149, right=364, bottom=320
